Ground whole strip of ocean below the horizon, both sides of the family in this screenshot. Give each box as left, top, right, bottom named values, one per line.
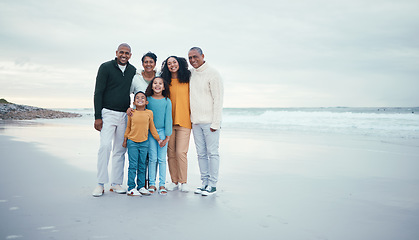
left=59, top=107, right=419, bottom=140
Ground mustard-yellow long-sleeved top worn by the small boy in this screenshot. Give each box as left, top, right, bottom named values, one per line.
left=124, top=109, right=160, bottom=142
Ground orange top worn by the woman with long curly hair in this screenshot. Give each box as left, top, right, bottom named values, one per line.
left=170, top=79, right=192, bottom=129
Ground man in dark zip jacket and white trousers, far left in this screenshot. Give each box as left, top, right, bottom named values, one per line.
left=92, top=43, right=136, bottom=197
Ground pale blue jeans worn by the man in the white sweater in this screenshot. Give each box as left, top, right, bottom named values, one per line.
left=192, top=124, right=220, bottom=187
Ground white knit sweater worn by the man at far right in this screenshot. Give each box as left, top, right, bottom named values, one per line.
left=189, top=62, right=224, bottom=129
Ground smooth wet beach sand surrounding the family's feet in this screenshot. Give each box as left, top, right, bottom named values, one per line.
left=0, top=119, right=419, bottom=240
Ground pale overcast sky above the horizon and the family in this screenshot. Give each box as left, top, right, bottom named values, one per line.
left=0, top=0, right=419, bottom=108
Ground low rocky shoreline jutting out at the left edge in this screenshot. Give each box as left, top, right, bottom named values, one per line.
left=0, top=103, right=81, bottom=120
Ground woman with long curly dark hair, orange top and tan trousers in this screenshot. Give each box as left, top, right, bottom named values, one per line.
left=161, top=56, right=192, bottom=192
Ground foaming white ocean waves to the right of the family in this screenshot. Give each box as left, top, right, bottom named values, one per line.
left=223, top=109, right=419, bottom=139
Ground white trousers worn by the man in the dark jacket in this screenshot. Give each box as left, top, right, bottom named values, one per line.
left=97, top=108, right=127, bottom=184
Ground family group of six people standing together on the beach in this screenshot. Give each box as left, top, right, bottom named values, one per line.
left=92, top=43, right=223, bottom=197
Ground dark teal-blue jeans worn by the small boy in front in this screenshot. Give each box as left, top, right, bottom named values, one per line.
left=127, top=139, right=149, bottom=191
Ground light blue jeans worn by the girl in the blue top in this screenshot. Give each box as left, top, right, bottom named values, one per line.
left=148, top=128, right=168, bottom=187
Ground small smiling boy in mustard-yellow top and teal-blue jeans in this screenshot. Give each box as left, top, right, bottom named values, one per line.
left=122, top=91, right=162, bottom=196
